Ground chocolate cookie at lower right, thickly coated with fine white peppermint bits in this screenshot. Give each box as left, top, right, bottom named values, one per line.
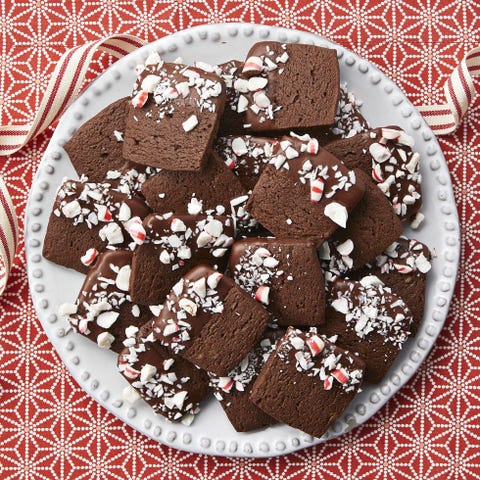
left=319, top=276, right=413, bottom=383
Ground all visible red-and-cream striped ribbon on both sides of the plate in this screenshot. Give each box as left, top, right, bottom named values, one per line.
left=0, top=34, right=480, bottom=295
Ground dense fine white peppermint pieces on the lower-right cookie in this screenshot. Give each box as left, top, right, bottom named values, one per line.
left=329, top=275, right=413, bottom=350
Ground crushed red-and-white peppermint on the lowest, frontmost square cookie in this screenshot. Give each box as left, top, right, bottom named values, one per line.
left=275, top=327, right=363, bottom=392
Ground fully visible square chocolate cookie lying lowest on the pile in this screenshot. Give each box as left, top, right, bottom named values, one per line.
left=250, top=327, right=364, bottom=437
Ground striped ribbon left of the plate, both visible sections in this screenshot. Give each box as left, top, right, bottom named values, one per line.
left=0, top=34, right=146, bottom=295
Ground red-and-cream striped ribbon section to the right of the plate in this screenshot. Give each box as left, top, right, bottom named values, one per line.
left=418, top=47, right=480, bottom=135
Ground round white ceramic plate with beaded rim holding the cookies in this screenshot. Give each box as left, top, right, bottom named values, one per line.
left=25, top=24, right=459, bottom=457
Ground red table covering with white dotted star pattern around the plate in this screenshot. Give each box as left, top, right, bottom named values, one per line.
left=0, top=0, right=480, bottom=480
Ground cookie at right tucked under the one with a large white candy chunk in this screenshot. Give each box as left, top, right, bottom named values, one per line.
left=319, top=169, right=402, bottom=275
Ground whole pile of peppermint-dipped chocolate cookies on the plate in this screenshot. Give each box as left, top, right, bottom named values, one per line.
left=47, top=42, right=430, bottom=437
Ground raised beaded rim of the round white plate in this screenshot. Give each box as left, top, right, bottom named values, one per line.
left=25, top=23, right=460, bottom=457
